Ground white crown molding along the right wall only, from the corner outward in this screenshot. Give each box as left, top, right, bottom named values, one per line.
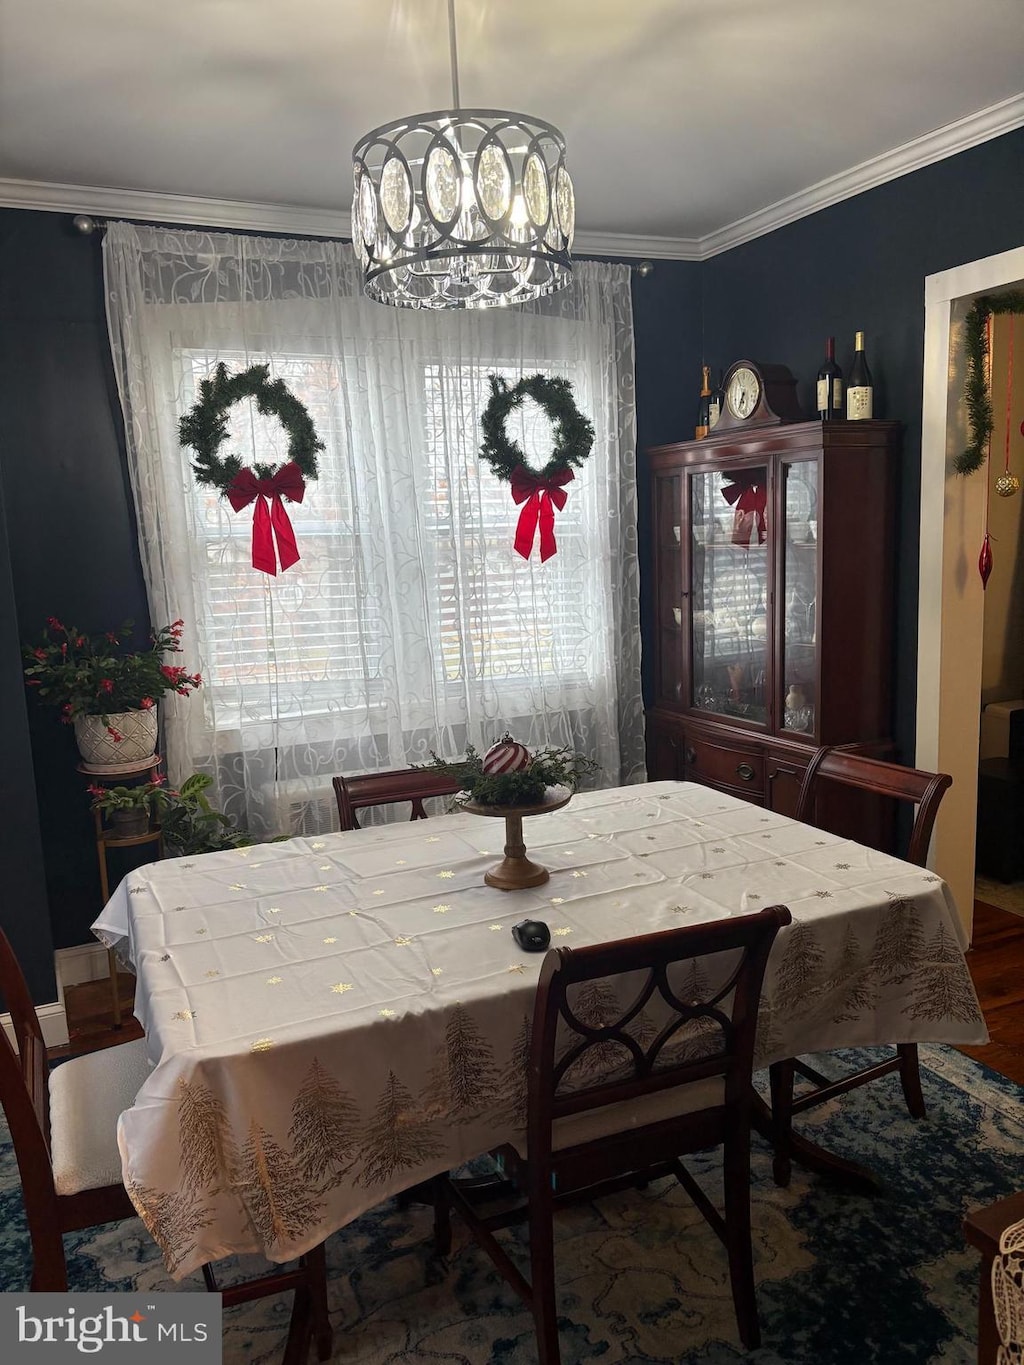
left=700, top=94, right=1024, bottom=261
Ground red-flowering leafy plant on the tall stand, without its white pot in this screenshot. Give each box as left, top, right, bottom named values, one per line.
left=22, top=616, right=202, bottom=728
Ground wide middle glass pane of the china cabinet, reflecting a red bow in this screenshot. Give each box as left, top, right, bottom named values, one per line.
left=689, top=465, right=769, bottom=725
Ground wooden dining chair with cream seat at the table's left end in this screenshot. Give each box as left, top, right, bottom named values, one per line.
left=0, top=930, right=332, bottom=1365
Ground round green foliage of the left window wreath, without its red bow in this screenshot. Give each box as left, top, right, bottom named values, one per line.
left=177, top=364, right=324, bottom=493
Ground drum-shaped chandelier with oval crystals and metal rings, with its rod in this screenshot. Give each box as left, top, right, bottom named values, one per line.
left=352, top=0, right=576, bottom=308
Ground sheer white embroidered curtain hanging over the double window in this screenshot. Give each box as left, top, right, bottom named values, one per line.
left=104, top=222, right=643, bottom=835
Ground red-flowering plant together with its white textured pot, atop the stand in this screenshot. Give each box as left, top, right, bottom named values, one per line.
left=22, top=616, right=202, bottom=770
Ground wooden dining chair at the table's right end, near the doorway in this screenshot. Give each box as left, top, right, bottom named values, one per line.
left=770, top=745, right=953, bottom=1185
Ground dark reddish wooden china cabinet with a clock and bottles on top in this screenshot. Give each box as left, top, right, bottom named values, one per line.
left=647, top=422, right=900, bottom=819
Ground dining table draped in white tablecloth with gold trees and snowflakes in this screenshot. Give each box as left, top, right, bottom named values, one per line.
left=93, top=782, right=987, bottom=1279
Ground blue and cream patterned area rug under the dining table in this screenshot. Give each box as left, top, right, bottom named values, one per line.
left=0, top=1047, right=1024, bottom=1365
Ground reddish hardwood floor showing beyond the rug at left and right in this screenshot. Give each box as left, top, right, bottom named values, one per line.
left=51, top=901, right=1024, bottom=1085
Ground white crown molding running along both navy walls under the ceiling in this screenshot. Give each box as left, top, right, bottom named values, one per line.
left=0, top=94, right=1024, bottom=261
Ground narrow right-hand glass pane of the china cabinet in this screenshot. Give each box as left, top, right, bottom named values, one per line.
left=778, top=460, right=818, bottom=734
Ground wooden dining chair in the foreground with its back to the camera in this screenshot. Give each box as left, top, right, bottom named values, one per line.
left=436, top=905, right=791, bottom=1365
